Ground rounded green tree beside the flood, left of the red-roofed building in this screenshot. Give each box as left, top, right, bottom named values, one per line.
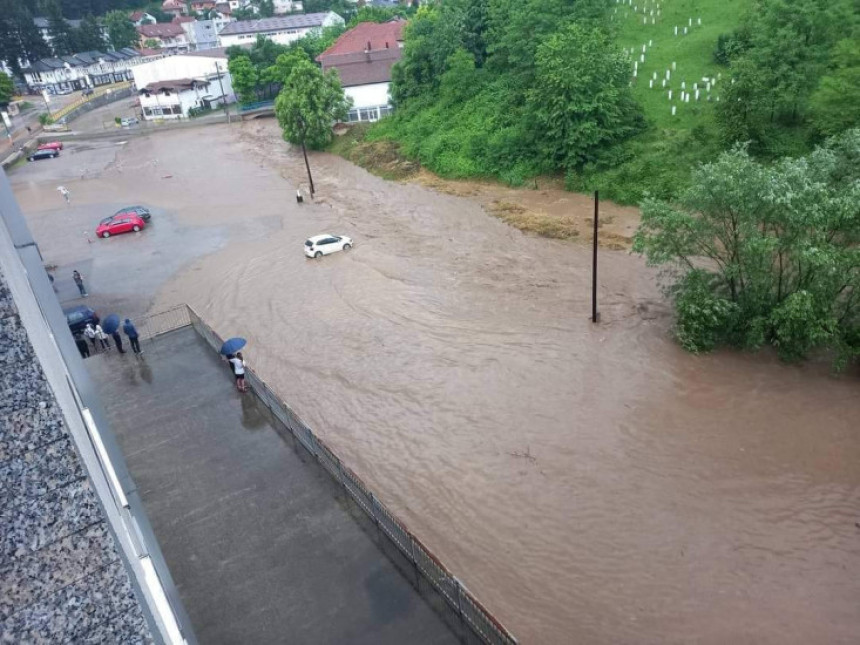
left=275, top=52, right=350, bottom=149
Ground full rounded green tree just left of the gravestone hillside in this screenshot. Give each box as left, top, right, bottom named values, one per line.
left=527, top=23, right=642, bottom=169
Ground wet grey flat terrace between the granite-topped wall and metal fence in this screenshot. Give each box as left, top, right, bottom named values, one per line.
left=85, top=327, right=459, bottom=645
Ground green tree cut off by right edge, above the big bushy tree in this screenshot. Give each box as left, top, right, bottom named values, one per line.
left=810, top=38, right=860, bottom=135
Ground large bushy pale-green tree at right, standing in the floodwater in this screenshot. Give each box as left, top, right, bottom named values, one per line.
left=634, top=130, right=860, bottom=366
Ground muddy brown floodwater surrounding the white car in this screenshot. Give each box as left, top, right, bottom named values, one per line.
left=11, top=122, right=860, bottom=645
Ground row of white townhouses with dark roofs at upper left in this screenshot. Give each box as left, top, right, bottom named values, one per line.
left=21, top=47, right=144, bottom=94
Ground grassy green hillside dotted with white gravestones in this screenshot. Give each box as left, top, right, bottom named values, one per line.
left=570, top=0, right=752, bottom=203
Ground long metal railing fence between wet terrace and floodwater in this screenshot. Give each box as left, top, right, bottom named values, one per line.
left=138, top=305, right=517, bottom=645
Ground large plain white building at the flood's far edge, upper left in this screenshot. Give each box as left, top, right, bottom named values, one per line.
left=132, top=49, right=235, bottom=120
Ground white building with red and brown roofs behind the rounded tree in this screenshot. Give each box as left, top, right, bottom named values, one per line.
left=317, top=20, right=406, bottom=121
